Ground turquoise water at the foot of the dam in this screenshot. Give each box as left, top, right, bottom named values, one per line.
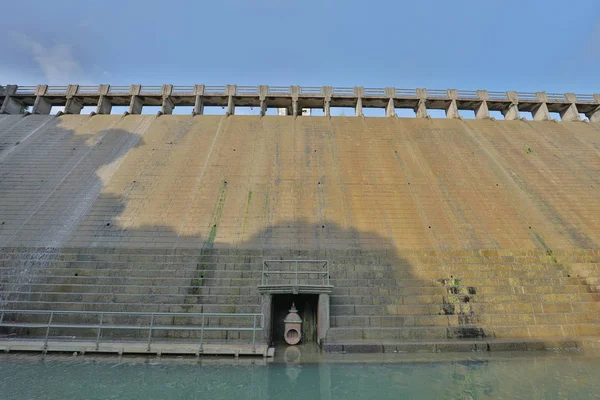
left=0, top=353, right=600, bottom=400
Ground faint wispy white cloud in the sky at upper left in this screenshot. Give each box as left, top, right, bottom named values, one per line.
left=11, top=32, right=82, bottom=85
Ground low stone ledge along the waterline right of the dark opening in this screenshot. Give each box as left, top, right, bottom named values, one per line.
left=321, top=338, right=600, bottom=353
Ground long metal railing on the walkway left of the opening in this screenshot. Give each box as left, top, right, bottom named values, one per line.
left=0, top=310, right=264, bottom=353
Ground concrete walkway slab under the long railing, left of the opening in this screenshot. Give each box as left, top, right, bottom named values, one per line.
left=0, top=339, right=274, bottom=357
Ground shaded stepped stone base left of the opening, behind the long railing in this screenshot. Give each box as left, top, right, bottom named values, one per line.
left=0, top=248, right=262, bottom=340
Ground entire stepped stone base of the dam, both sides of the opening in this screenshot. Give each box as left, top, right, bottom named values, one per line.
left=0, top=248, right=600, bottom=346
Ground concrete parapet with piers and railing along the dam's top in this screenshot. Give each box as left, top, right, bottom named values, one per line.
left=0, top=85, right=600, bottom=122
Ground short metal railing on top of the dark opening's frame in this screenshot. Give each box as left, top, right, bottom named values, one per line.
left=260, top=260, right=329, bottom=287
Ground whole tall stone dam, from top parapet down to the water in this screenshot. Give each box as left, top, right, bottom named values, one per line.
left=0, top=85, right=600, bottom=356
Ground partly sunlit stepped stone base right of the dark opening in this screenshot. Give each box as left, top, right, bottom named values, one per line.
left=328, top=250, right=600, bottom=343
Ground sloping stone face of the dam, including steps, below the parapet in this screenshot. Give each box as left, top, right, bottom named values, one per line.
left=0, top=115, right=600, bottom=350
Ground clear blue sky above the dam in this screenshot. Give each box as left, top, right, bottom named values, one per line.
left=0, top=0, right=600, bottom=93
